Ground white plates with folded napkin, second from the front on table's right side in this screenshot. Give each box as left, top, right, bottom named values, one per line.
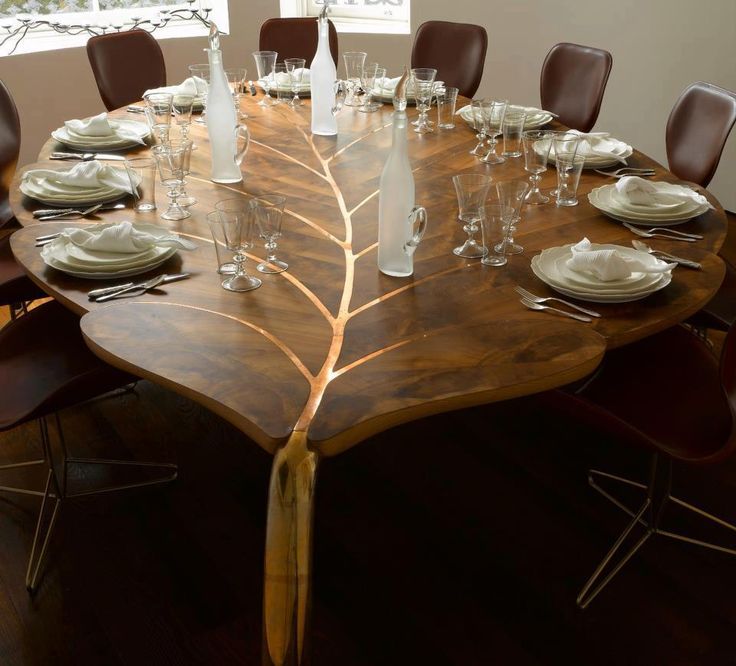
left=588, top=176, right=713, bottom=228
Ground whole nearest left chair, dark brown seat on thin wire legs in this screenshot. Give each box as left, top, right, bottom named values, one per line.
left=0, top=301, right=177, bottom=593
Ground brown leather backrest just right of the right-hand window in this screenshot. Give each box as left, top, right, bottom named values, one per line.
left=411, top=21, right=488, bottom=97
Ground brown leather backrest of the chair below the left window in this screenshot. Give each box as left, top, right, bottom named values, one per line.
left=87, top=30, right=166, bottom=111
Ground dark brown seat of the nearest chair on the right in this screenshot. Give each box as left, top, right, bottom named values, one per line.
left=546, top=326, right=732, bottom=463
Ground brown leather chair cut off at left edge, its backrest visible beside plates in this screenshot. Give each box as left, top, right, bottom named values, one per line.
left=0, top=81, right=46, bottom=318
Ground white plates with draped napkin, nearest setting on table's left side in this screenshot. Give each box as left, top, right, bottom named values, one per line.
left=36, top=221, right=197, bottom=278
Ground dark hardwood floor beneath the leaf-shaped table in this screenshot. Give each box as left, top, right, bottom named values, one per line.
left=0, top=215, right=736, bottom=666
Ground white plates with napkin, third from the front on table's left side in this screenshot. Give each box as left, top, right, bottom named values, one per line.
left=51, top=113, right=151, bottom=151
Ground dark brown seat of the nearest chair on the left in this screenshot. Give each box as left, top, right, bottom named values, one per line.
left=0, top=301, right=135, bottom=430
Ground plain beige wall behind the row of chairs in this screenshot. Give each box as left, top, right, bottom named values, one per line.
left=0, top=0, right=736, bottom=210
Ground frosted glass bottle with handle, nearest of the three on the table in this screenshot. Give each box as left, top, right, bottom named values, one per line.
left=378, top=73, right=427, bottom=277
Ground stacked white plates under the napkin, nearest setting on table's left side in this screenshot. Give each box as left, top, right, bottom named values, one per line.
left=41, top=224, right=177, bottom=280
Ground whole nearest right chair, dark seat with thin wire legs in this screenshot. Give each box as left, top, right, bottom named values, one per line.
left=543, top=326, right=736, bottom=608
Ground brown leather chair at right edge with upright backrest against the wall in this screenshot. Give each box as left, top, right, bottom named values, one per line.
left=665, top=81, right=736, bottom=331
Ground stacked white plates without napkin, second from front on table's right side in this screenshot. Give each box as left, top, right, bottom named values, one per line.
left=588, top=183, right=710, bottom=227
